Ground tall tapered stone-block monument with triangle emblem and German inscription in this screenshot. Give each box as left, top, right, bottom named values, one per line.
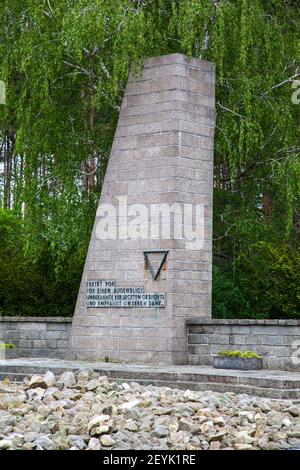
left=69, top=54, right=215, bottom=364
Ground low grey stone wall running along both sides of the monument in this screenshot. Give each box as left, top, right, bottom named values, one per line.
left=0, top=317, right=300, bottom=370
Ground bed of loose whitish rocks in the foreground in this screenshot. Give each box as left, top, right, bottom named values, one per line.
left=0, top=369, right=300, bottom=450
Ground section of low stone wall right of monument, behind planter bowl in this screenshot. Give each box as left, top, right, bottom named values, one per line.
left=187, top=318, right=300, bottom=370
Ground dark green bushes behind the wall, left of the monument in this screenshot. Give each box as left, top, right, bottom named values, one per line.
left=0, top=210, right=86, bottom=316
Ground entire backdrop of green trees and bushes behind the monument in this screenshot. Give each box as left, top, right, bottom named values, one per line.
left=0, top=0, right=300, bottom=318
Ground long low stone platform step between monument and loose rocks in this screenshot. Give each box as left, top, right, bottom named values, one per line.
left=0, top=358, right=300, bottom=401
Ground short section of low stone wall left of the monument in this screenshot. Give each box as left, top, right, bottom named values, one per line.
left=0, top=317, right=72, bottom=359
